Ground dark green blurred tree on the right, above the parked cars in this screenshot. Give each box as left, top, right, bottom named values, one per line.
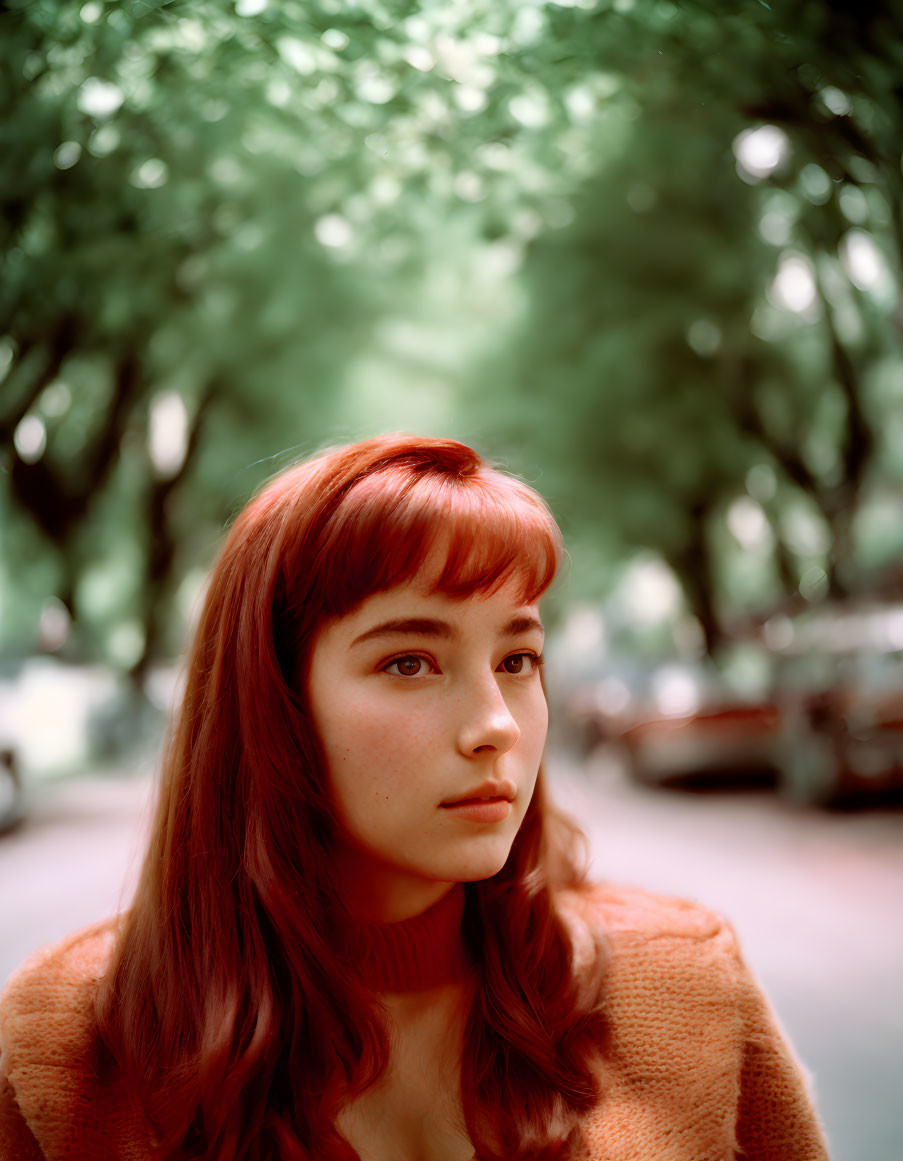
left=492, top=2, right=903, bottom=647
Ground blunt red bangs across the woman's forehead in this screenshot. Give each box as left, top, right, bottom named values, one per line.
left=315, top=464, right=562, bottom=616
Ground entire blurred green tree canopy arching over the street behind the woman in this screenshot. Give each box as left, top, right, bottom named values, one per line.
left=0, top=0, right=903, bottom=676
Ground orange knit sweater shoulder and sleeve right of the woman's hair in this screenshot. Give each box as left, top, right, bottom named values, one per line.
left=562, top=884, right=828, bottom=1161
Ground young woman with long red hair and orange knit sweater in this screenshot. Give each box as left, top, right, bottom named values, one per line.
left=0, top=437, right=826, bottom=1161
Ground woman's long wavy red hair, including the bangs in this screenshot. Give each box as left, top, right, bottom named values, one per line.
left=96, top=435, right=604, bottom=1161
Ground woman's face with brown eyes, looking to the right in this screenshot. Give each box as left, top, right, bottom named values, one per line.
left=308, top=568, right=548, bottom=922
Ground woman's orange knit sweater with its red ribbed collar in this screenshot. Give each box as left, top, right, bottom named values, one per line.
left=0, top=887, right=828, bottom=1161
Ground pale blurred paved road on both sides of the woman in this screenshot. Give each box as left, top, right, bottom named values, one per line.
left=0, top=758, right=903, bottom=1161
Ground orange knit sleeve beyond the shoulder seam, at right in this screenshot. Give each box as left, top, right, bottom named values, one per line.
left=737, top=942, right=829, bottom=1161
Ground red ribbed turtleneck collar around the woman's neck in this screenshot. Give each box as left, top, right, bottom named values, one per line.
left=345, top=884, right=471, bottom=991
